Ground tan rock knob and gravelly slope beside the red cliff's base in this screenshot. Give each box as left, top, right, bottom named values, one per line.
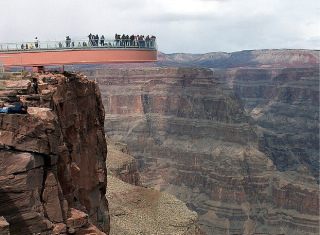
left=107, top=139, right=200, bottom=235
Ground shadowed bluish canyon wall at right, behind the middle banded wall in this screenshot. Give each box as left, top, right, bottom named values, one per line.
left=214, top=67, right=319, bottom=179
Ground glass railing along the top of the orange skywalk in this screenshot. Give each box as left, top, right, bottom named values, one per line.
left=0, top=39, right=157, bottom=53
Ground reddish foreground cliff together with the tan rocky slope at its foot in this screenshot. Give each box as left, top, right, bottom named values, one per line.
left=0, top=72, right=200, bottom=235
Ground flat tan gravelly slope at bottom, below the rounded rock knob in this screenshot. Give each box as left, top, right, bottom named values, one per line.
left=107, top=175, right=200, bottom=234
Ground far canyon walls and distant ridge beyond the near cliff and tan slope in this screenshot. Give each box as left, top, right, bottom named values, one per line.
left=80, top=50, right=319, bottom=234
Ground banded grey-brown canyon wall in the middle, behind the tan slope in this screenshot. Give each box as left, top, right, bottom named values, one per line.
left=91, top=68, right=319, bottom=234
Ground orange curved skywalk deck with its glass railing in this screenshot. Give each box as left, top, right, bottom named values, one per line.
left=0, top=40, right=157, bottom=67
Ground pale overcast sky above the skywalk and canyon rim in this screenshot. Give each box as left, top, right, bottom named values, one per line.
left=0, top=0, right=320, bottom=53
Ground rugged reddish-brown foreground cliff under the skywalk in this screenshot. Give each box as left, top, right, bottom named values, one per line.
left=0, top=73, right=110, bottom=234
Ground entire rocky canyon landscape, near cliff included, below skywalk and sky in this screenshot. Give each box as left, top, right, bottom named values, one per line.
left=0, top=50, right=320, bottom=235
